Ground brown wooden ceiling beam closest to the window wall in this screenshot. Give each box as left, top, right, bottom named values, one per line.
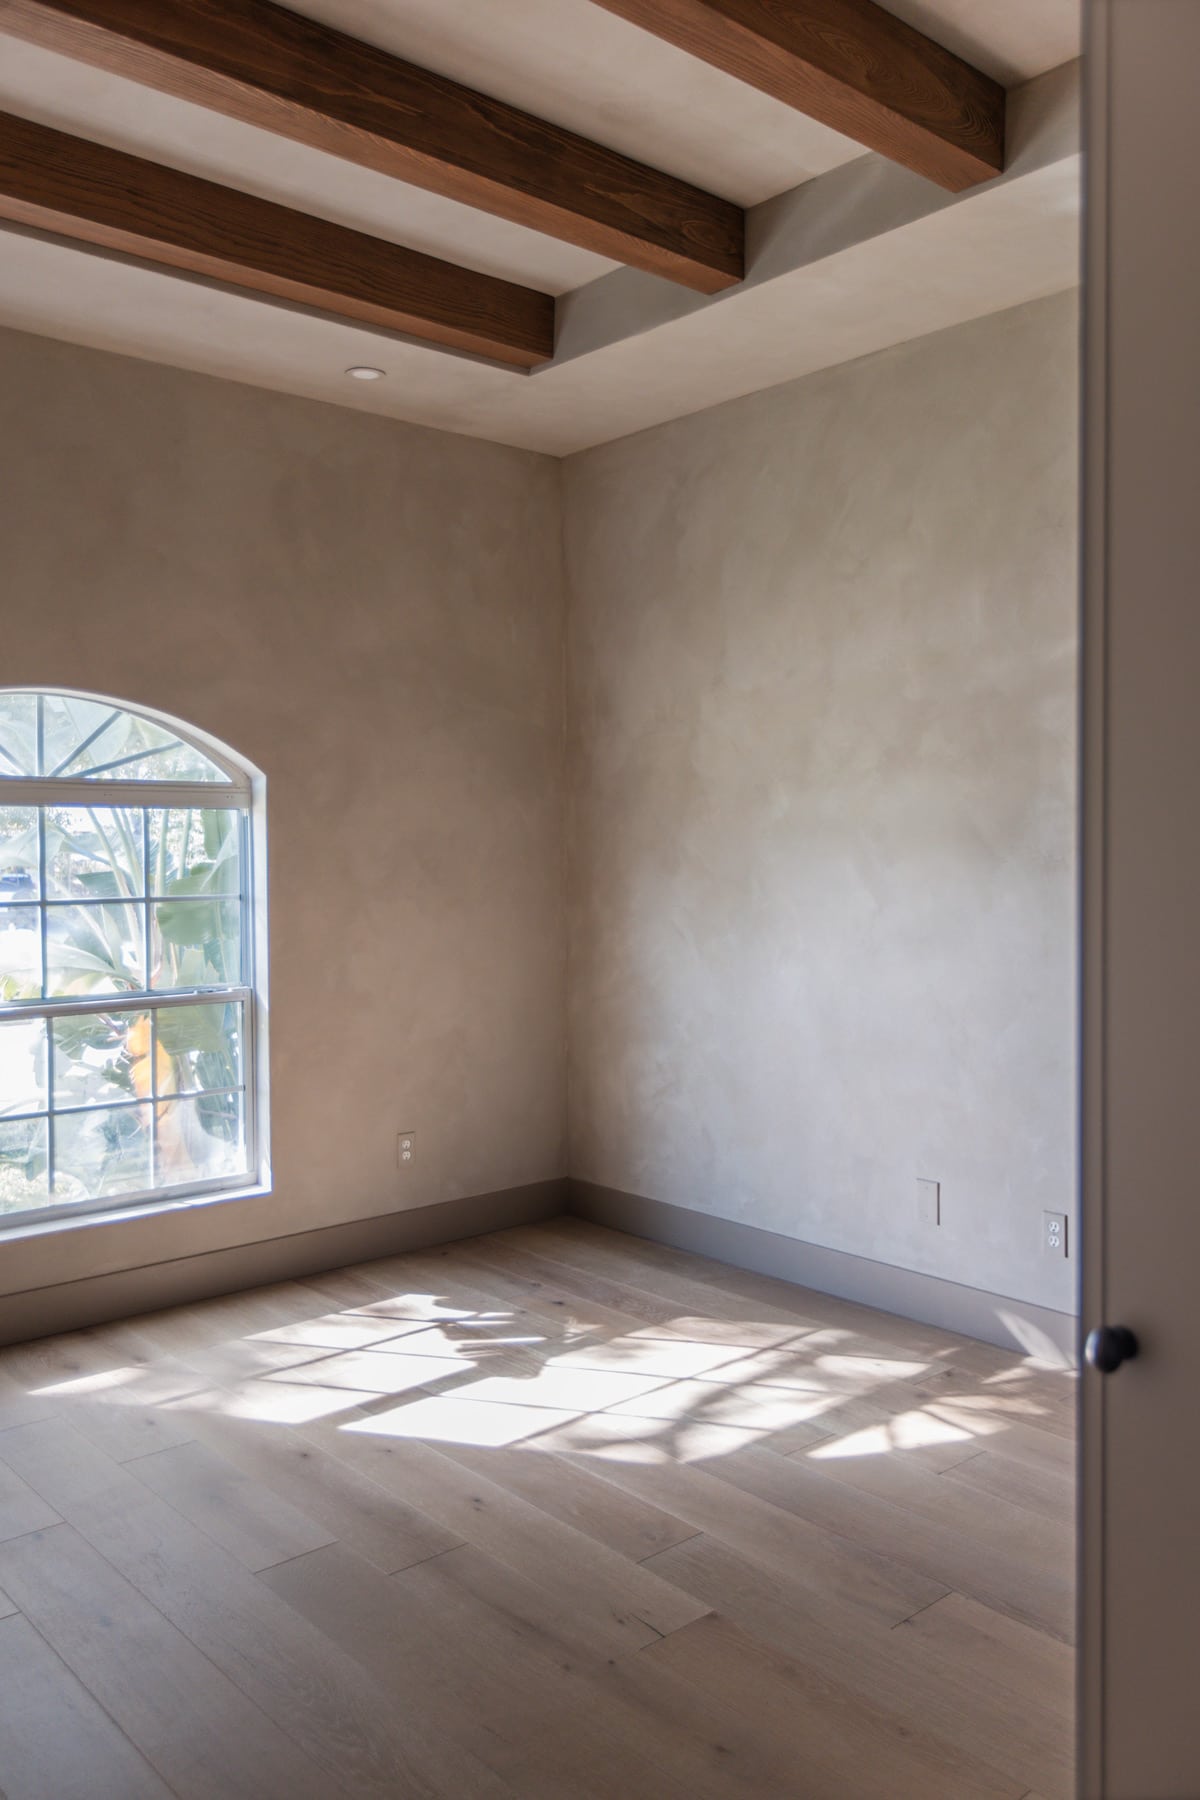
left=0, top=113, right=554, bottom=369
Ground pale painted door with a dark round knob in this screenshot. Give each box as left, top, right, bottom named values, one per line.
left=1079, top=0, right=1200, bottom=1800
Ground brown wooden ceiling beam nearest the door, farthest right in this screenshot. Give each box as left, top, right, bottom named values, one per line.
left=597, top=0, right=1004, bottom=193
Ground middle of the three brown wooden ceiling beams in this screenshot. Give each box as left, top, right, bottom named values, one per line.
left=0, top=0, right=745, bottom=293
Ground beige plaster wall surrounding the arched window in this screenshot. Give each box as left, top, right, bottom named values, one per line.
left=0, top=333, right=565, bottom=1292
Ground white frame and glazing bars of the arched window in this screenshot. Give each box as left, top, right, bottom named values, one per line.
left=0, top=688, right=268, bottom=1237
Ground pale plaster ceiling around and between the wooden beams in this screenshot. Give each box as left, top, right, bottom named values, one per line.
left=0, top=0, right=1079, bottom=454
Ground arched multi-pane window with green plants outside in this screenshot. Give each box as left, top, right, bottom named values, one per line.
left=0, top=691, right=257, bottom=1215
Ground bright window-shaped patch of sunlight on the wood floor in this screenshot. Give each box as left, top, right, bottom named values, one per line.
left=7, top=1291, right=1079, bottom=1467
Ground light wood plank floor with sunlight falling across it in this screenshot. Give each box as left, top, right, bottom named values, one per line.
left=0, top=1219, right=1074, bottom=1800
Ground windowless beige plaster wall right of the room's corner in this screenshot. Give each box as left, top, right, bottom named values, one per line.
left=565, top=295, right=1078, bottom=1310
